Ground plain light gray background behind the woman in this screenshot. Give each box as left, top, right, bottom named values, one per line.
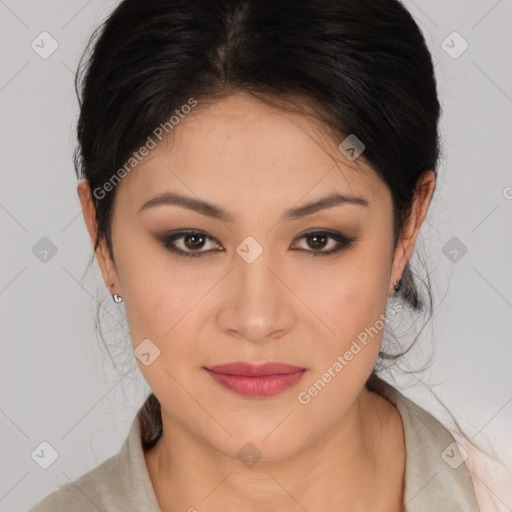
left=0, top=0, right=512, bottom=511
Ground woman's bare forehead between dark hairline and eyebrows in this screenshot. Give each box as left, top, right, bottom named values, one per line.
left=117, top=93, right=387, bottom=208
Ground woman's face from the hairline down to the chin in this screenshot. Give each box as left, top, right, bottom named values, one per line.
left=82, top=94, right=430, bottom=459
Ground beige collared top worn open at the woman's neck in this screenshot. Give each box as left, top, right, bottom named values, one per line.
left=29, top=378, right=480, bottom=512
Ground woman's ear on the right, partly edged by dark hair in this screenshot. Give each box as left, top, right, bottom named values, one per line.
left=389, top=170, right=436, bottom=290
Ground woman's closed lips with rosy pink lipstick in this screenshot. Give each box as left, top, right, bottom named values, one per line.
left=204, top=361, right=306, bottom=398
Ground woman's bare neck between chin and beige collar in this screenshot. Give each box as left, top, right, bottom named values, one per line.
left=145, top=388, right=405, bottom=512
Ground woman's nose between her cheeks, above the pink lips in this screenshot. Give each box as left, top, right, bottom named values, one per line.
left=217, top=250, right=300, bottom=343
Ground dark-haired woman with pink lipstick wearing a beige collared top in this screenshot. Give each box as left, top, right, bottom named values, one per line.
left=32, top=0, right=479, bottom=512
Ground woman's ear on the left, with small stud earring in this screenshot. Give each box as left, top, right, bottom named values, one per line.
left=77, top=179, right=121, bottom=294
